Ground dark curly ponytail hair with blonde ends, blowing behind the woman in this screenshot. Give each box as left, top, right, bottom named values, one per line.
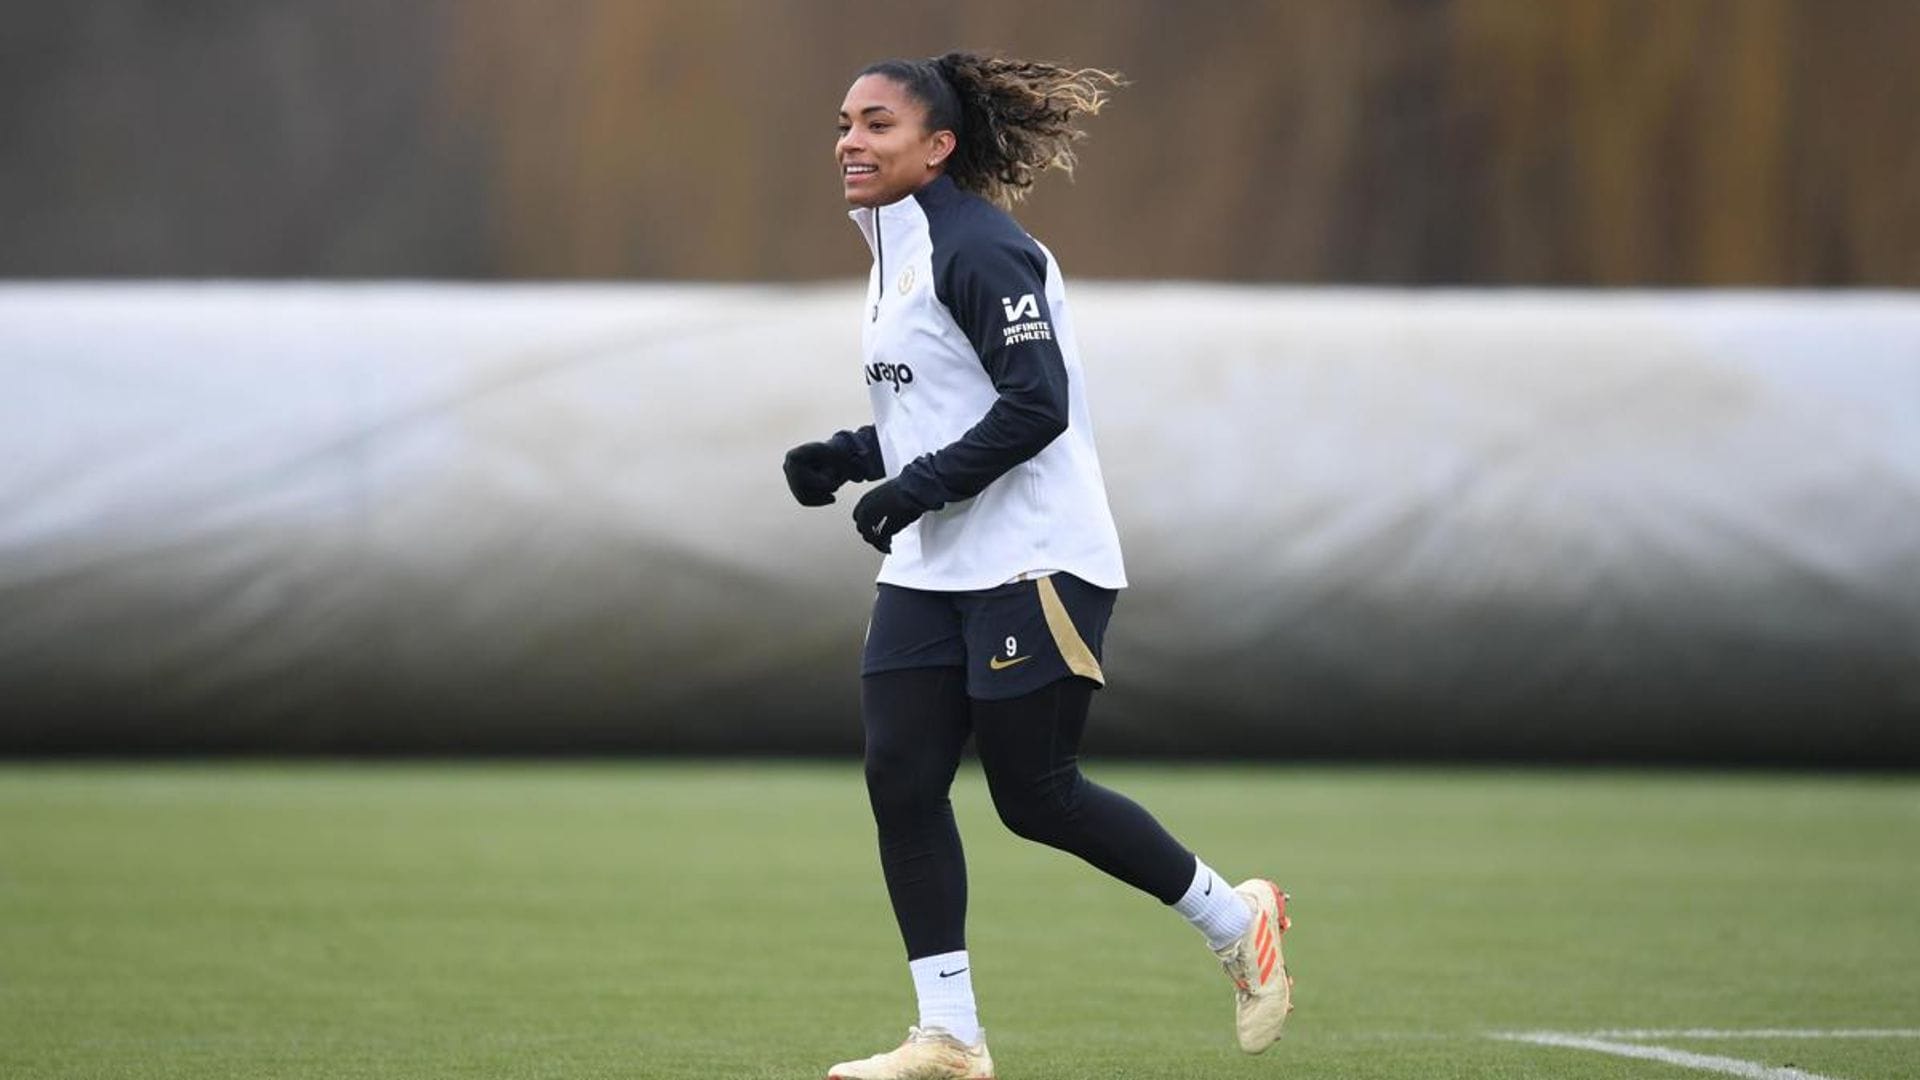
left=860, top=52, right=1125, bottom=208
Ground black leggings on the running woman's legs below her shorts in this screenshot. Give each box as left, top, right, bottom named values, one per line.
left=860, top=667, right=1194, bottom=959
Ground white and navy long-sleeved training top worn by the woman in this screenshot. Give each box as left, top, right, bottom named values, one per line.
left=833, top=175, right=1127, bottom=592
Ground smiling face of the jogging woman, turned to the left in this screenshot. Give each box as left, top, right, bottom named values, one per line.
left=833, top=75, right=954, bottom=206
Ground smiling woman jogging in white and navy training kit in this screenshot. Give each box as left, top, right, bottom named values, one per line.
left=785, top=52, right=1292, bottom=1080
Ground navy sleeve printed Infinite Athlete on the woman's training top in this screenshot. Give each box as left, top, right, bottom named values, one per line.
left=900, top=216, right=1068, bottom=509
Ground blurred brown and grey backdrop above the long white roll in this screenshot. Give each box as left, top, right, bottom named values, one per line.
left=0, top=0, right=1920, bottom=286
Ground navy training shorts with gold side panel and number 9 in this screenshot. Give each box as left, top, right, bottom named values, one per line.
left=860, top=573, right=1119, bottom=701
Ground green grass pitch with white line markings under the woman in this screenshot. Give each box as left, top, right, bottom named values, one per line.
left=0, top=761, right=1920, bottom=1080
